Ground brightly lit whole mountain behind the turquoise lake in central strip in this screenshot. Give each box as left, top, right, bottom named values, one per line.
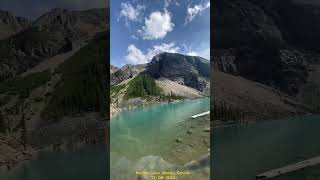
left=110, top=52, right=210, bottom=115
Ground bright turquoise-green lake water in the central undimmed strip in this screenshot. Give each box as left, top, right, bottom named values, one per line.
left=110, top=98, right=210, bottom=179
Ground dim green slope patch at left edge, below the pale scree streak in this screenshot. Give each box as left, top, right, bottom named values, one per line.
left=0, top=71, right=51, bottom=98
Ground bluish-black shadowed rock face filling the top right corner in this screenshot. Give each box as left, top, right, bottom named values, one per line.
left=250, top=0, right=320, bottom=49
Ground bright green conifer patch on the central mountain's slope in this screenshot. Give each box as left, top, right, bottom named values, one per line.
left=125, top=74, right=162, bottom=99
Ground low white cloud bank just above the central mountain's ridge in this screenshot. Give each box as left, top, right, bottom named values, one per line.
left=126, top=43, right=180, bottom=64
